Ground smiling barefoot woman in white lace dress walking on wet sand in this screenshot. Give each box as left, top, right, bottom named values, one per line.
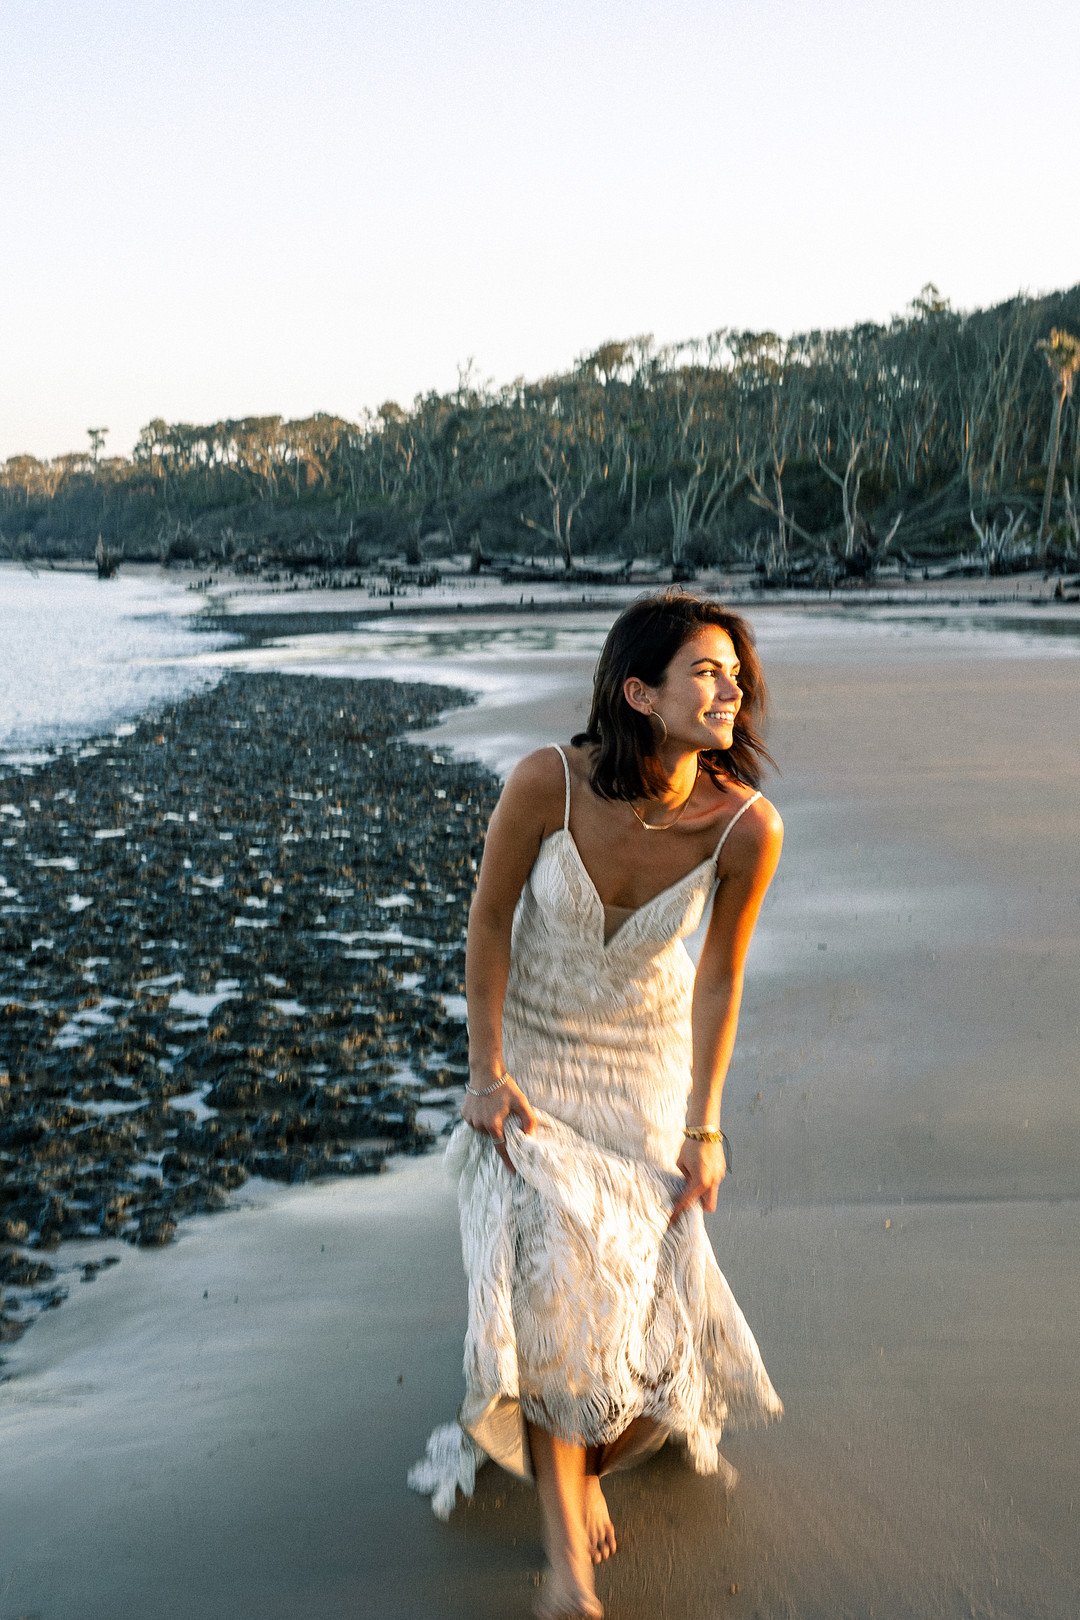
left=410, top=590, right=782, bottom=1617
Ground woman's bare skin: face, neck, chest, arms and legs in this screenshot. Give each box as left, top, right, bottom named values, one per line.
left=461, top=625, right=784, bottom=1617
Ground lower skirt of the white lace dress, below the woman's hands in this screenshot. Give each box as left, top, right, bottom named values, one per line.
left=408, top=1113, right=784, bottom=1518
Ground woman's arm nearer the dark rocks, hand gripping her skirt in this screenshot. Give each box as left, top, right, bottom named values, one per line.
left=461, top=748, right=563, bottom=1165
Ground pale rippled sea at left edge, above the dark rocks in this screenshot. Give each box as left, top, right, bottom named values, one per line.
left=0, top=565, right=230, bottom=760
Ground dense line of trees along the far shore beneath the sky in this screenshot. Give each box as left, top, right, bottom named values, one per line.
left=0, top=285, right=1080, bottom=580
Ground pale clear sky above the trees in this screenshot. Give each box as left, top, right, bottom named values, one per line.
left=0, top=0, right=1080, bottom=458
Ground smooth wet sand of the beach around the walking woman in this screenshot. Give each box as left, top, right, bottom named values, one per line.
left=0, top=609, right=1080, bottom=1620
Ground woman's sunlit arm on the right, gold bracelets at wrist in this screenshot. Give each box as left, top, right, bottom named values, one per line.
left=672, top=799, right=784, bottom=1220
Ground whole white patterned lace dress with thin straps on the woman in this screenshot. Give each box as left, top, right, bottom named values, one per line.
left=408, top=748, right=782, bottom=1518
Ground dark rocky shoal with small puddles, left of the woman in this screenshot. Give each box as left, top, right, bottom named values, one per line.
left=0, top=674, right=497, bottom=1367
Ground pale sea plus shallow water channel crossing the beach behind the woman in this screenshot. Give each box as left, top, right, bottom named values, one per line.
left=0, top=564, right=1080, bottom=760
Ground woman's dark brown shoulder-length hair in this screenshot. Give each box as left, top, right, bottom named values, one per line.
left=572, top=586, right=776, bottom=799
